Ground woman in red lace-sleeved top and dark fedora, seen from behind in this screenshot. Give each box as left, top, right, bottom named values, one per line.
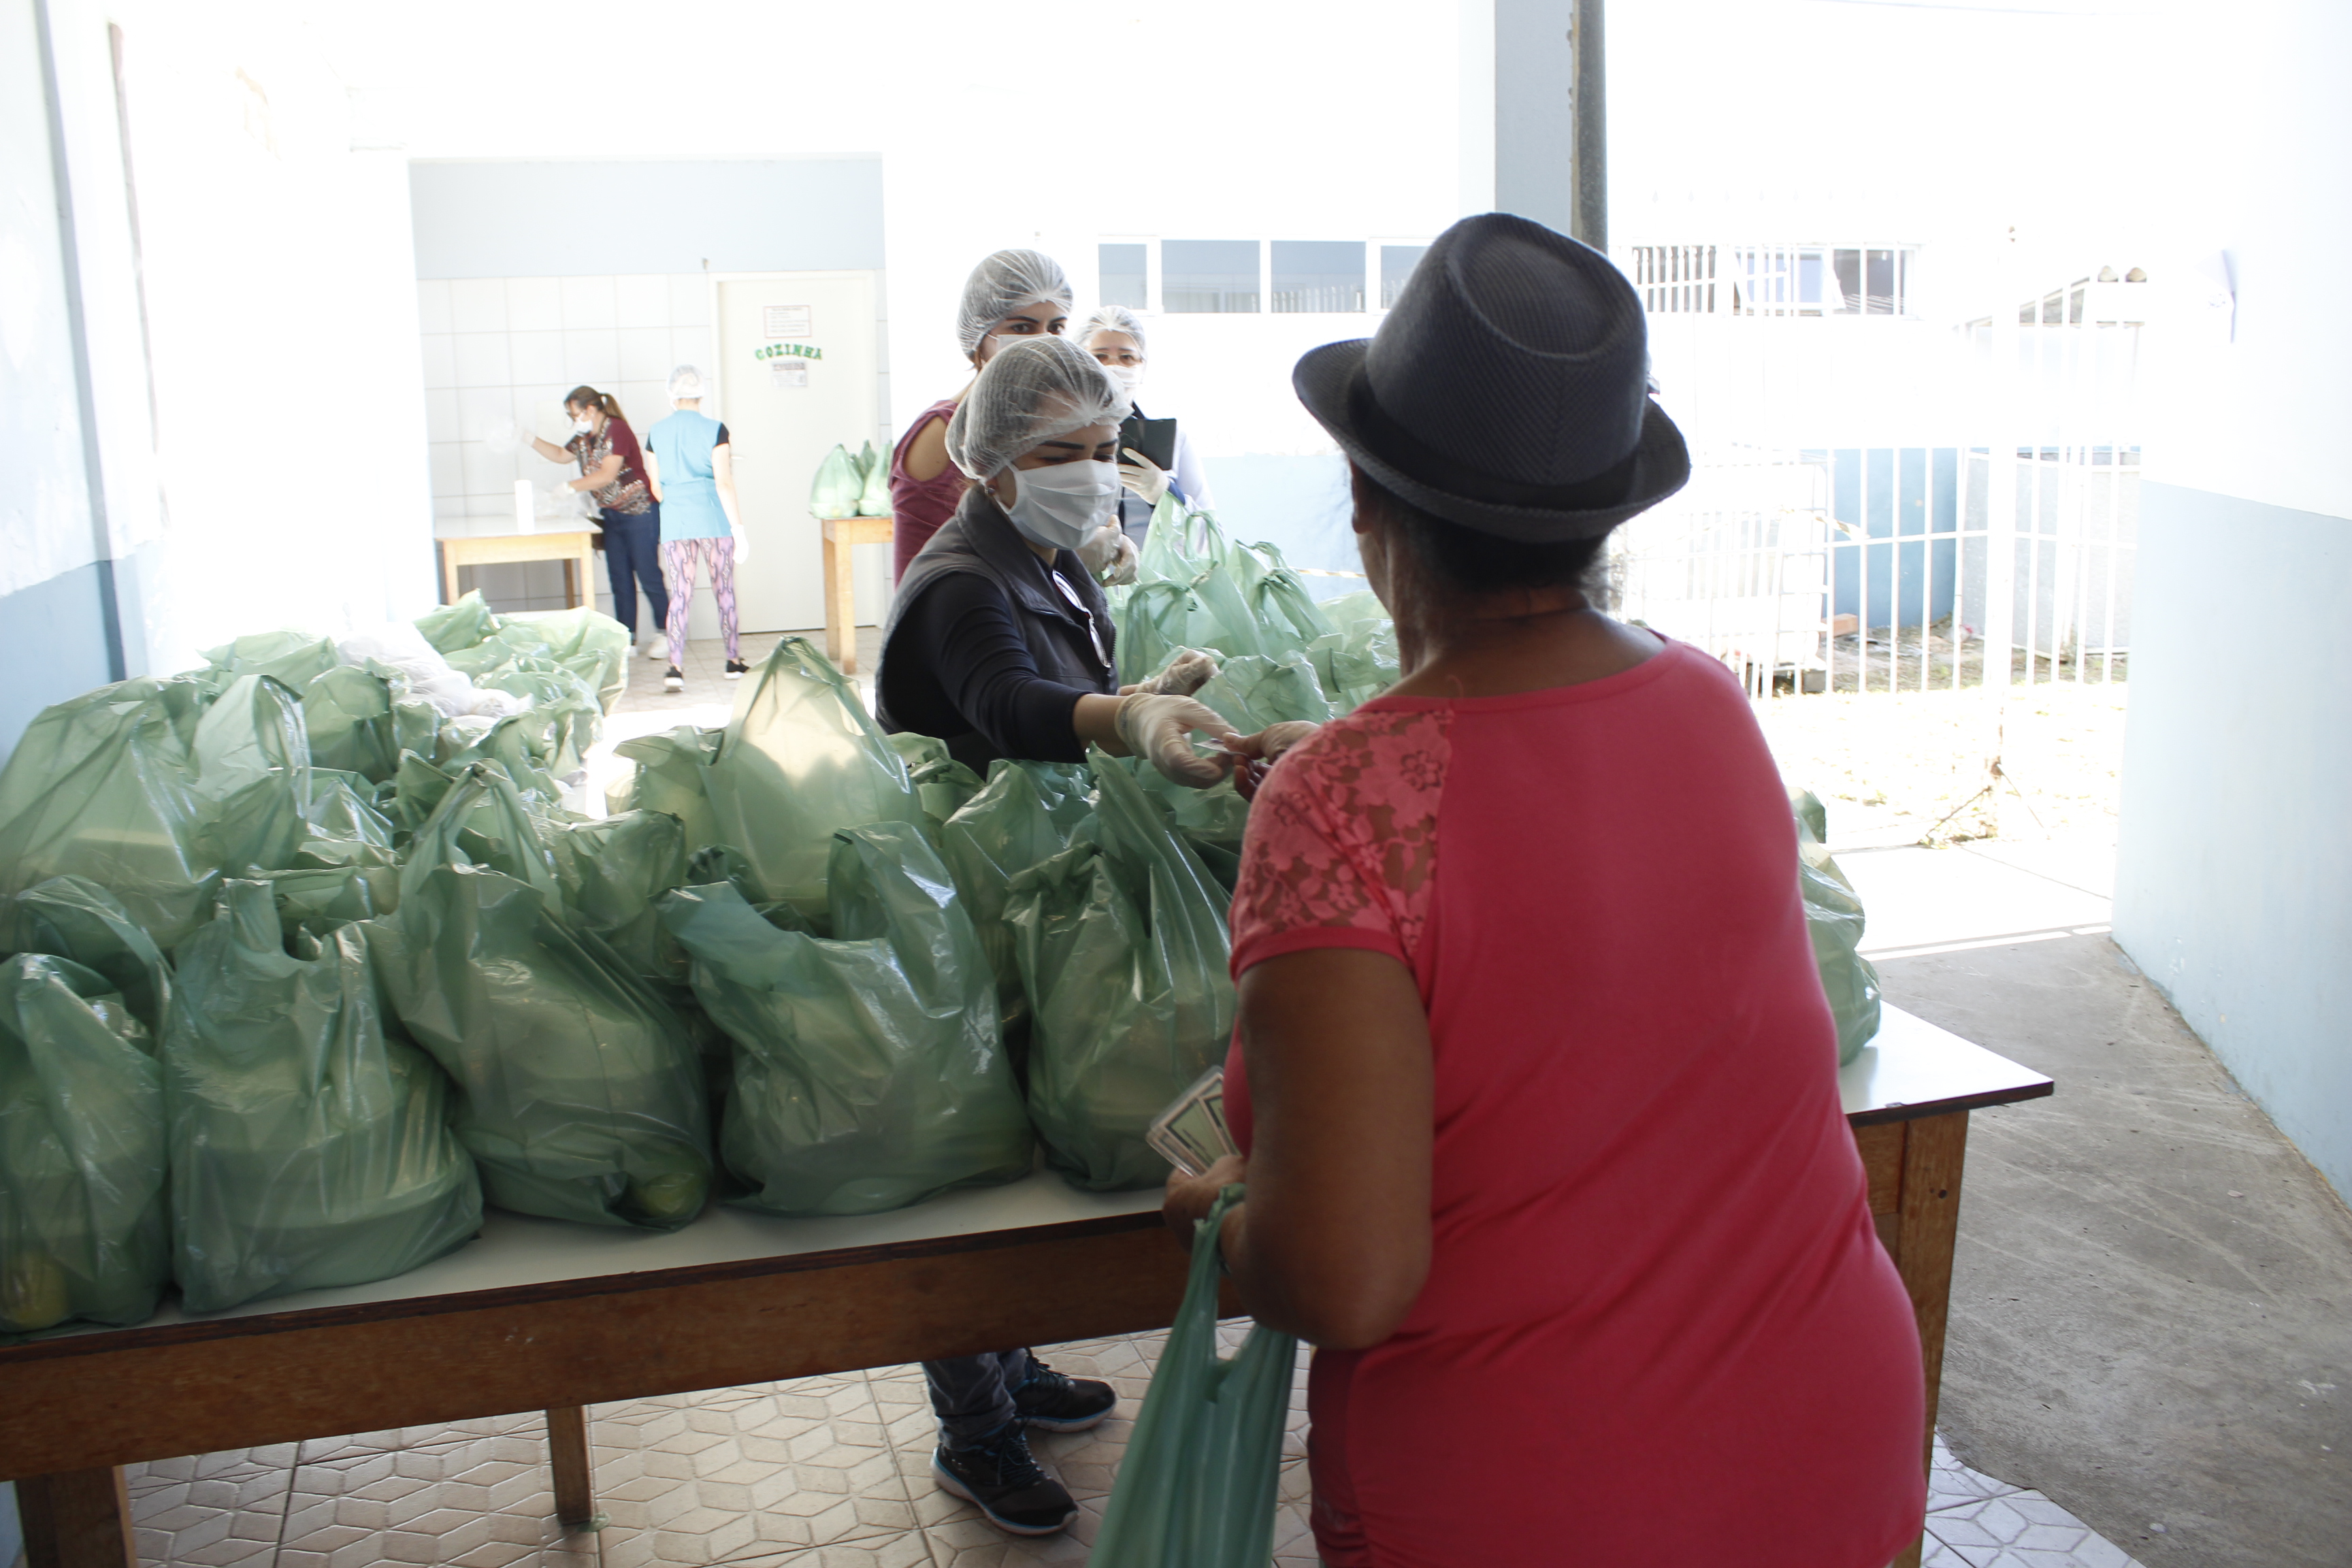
left=1166, top=214, right=1926, bottom=1568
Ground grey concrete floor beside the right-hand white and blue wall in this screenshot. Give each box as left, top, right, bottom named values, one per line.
left=1832, top=846, right=2352, bottom=1568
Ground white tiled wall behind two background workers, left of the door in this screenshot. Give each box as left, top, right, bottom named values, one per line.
left=416, top=273, right=717, bottom=609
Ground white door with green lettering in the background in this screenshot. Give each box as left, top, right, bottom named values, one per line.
left=715, top=273, right=889, bottom=632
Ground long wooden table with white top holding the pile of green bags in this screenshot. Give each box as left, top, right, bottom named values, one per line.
left=0, top=1009, right=2051, bottom=1568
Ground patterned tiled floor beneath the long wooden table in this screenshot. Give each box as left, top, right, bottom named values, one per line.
left=105, top=1324, right=2136, bottom=1568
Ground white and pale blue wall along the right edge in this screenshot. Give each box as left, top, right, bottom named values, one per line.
left=2114, top=0, right=2352, bottom=1194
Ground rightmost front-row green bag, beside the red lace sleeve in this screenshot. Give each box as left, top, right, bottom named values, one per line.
left=1004, top=752, right=1235, bottom=1192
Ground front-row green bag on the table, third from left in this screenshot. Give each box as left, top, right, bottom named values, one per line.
left=367, top=766, right=710, bottom=1230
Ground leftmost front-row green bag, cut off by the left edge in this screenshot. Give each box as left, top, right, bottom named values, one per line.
left=0, top=952, right=172, bottom=1337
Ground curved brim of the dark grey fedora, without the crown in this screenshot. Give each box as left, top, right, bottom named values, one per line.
left=1291, top=338, right=1691, bottom=545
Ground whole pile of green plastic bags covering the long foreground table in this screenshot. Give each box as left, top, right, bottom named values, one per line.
left=0, top=493, right=1877, bottom=1340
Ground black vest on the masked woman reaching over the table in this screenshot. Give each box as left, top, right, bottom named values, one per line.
left=875, top=487, right=1120, bottom=773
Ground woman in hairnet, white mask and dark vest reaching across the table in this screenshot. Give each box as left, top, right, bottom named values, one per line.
left=875, top=336, right=1235, bottom=1535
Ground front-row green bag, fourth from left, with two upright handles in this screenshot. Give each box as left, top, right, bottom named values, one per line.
left=664, top=823, right=1035, bottom=1215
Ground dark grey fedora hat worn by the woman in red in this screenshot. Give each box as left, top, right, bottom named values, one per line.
left=1291, top=212, right=1691, bottom=543
